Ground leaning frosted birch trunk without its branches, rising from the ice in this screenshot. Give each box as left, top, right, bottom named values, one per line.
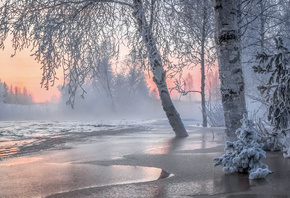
left=134, top=0, right=188, bottom=137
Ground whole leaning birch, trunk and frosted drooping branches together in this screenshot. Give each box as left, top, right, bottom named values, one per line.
left=0, top=0, right=188, bottom=136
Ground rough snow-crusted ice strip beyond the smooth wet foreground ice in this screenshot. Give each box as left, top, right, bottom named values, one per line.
left=0, top=120, right=153, bottom=161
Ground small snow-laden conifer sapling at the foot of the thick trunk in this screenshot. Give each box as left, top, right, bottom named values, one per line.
left=213, top=114, right=272, bottom=179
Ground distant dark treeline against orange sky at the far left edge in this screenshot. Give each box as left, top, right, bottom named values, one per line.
left=0, top=80, right=34, bottom=105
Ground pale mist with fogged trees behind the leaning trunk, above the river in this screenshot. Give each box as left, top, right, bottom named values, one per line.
left=0, top=55, right=201, bottom=121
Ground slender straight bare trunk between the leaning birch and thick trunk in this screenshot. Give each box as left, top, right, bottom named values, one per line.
left=200, top=3, right=207, bottom=127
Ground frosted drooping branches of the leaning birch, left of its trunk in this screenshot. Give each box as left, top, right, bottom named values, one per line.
left=0, top=0, right=134, bottom=104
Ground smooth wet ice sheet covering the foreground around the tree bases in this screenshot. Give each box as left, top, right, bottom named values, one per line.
left=0, top=125, right=290, bottom=198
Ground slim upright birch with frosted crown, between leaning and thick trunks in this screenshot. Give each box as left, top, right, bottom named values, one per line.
left=168, top=0, right=215, bottom=127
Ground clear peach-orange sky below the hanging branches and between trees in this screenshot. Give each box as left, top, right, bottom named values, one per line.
left=0, top=39, right=200, bottom=103
